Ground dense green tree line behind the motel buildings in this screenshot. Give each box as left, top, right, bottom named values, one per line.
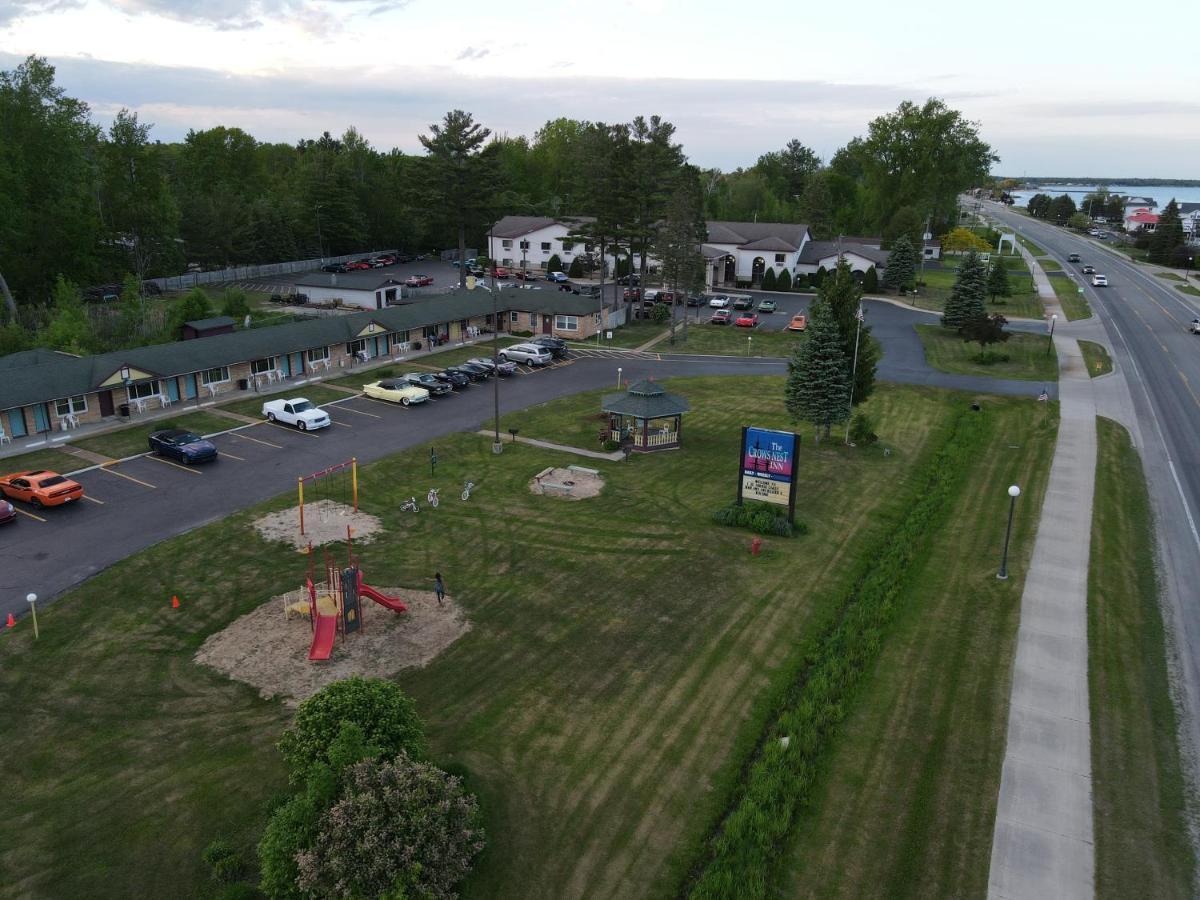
left=0, top=56, right=997, bottom=319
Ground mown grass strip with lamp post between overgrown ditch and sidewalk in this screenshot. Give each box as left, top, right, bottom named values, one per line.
left=772, top=398, right=1057, bottom=898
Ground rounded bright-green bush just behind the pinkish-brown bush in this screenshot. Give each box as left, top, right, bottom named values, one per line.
left=278, top=676, right=426, bottom=784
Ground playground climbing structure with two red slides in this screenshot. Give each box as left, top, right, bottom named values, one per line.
left=290, top=527, right=408, bottom=661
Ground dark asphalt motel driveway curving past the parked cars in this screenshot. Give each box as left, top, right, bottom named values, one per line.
left=0, top=303, right=1042, bottom=617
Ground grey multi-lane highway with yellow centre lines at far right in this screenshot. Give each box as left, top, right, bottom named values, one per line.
left=988, top=204, right=1200, bottom=766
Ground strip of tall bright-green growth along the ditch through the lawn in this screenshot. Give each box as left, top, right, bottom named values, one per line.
left=685, top=410, right=991, bottom=900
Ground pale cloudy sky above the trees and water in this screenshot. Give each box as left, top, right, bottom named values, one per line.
left=0, top=0, right=1200, bottom=178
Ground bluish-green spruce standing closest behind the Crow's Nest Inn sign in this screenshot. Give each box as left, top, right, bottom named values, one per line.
left=784, top=299, right=850, bottom=438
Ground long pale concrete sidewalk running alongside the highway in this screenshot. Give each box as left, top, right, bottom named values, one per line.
left=988, top=247, right=1096, bottom=900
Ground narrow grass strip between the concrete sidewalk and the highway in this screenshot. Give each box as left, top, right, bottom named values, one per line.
left=1087, top=419, right=1195, bottom=900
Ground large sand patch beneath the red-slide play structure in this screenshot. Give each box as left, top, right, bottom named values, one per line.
left=194, top=587, right=470, bottom=706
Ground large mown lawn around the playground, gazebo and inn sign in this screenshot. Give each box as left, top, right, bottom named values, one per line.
left=0, top=377, right=974, bottom=898
